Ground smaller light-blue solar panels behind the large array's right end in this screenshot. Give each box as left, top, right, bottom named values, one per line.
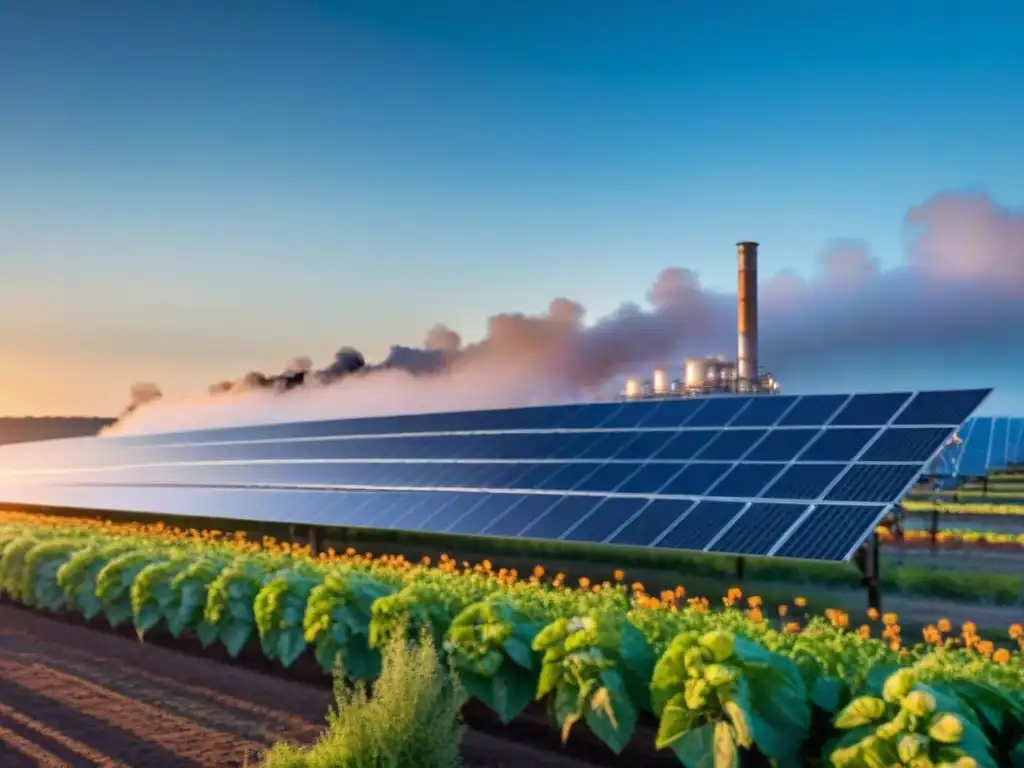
left=926, top=417, right=1024, bottom=477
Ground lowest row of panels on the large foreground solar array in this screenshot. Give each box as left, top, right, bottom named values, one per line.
left=0, top=485, right=885, bottom=560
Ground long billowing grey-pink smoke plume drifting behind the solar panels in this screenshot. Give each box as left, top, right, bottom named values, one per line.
left=105, top=194, right=1024, bottom=432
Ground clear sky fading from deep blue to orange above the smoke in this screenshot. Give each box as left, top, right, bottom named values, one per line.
left=0, top=0, right=1024, bottom=414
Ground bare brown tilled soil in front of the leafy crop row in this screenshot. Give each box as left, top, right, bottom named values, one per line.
left=0, top=605, right=588, bottom=768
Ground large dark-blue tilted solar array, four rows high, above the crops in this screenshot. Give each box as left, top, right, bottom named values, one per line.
left=0, top=390, right=989, bottom=560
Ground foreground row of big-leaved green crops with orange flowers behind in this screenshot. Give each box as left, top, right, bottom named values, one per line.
left=0, top=516, right=1024, bottom=768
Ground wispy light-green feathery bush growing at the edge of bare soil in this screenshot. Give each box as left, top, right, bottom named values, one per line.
left=261, top=633, right=465, bottom=768
